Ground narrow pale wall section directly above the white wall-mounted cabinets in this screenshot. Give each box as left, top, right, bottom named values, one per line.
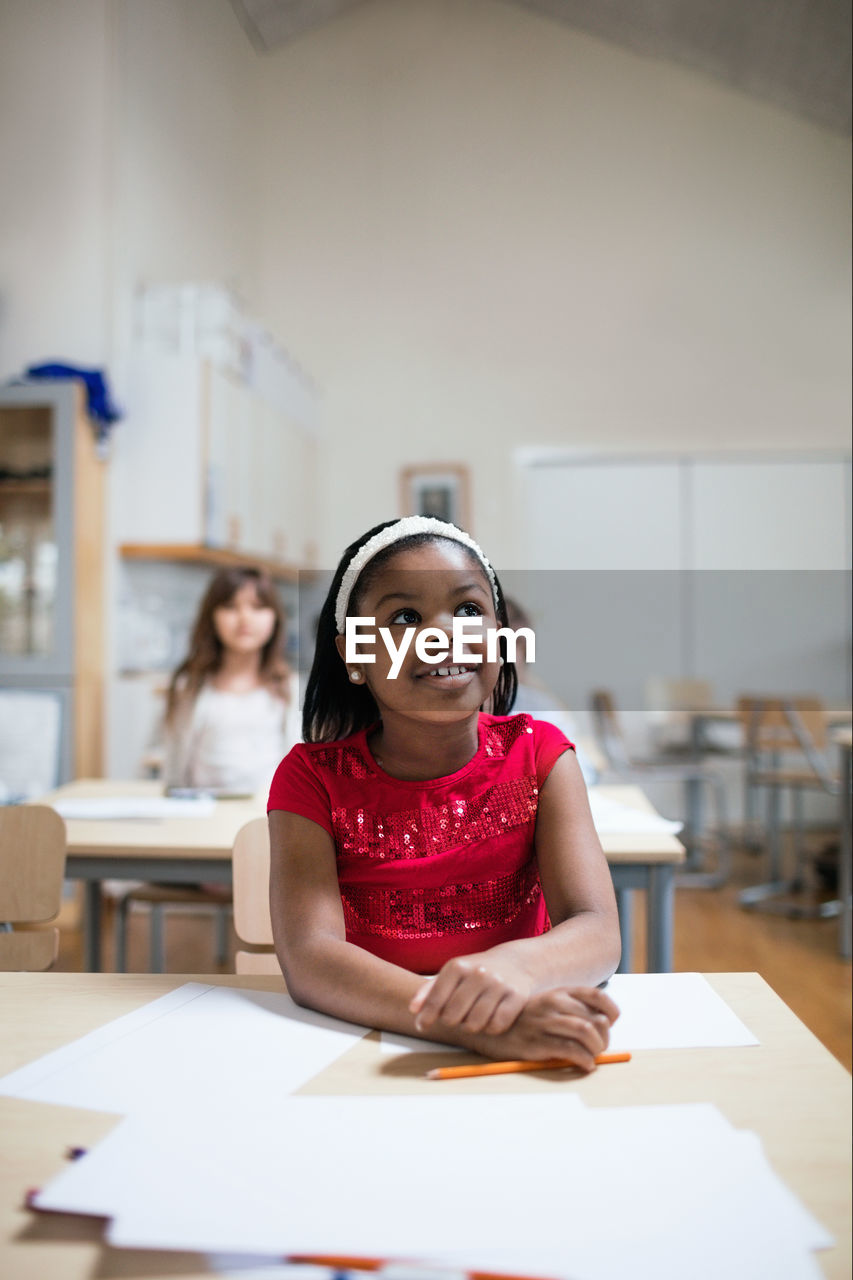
left=115, top=0, right=261, bottom=366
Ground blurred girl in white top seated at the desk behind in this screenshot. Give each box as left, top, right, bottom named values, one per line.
left=164, top=568, right=300, bottom=795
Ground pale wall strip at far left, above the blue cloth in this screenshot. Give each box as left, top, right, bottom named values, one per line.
left=0, top=0, right=110, bottom=378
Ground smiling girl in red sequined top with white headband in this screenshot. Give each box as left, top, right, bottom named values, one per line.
left=269, top=516, right=620, bottom=1071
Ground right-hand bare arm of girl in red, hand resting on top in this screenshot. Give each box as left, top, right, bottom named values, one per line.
left=411, top=751, right=620, bottom=1034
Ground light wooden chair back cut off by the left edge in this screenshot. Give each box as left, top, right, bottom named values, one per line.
left=0, top=805, right=65, bottom=970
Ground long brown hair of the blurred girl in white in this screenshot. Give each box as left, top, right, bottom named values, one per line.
left=167, top=566, right=291, bottom=723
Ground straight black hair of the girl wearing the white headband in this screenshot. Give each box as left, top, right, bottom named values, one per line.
left=302, top=517, right=517, bottom=742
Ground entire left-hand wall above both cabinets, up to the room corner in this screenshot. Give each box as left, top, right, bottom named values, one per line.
left=0, top=0, right=259, bottom=381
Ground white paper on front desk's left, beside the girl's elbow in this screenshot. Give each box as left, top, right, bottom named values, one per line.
left=0, top=983, right=366, bottom=1115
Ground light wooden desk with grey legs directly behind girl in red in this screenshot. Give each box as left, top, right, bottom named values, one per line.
left=38, top=778, right=684, bottom=973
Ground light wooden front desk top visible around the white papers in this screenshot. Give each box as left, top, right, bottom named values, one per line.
left=0, top=973, right=852, bottom=1280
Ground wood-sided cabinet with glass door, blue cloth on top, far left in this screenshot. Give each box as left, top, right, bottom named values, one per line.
left=0, top=381, right=106, bottom=777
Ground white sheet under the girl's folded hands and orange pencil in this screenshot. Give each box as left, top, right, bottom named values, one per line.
left=382, top=973, right=758, bottom=1053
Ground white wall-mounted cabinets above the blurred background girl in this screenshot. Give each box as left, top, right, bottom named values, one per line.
left=117, top=351, right=316, bottom=572
